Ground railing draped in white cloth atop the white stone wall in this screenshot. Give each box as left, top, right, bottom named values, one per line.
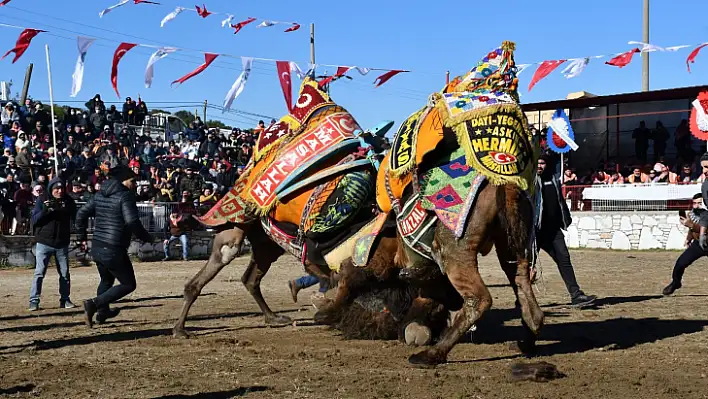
left=563, top=183, right=700, bottom=212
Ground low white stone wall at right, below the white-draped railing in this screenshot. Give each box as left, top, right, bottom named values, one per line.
left=565, top=211, right=688, bottom=250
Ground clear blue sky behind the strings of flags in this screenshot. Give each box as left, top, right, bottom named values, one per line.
left=0, top=0, right=708, bottom=134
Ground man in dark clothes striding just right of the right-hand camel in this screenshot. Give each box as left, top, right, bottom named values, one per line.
left=535, top=155, right=597, bottom=307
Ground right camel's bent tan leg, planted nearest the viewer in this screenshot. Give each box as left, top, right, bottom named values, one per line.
left=408, top=226, right=492, bottom=367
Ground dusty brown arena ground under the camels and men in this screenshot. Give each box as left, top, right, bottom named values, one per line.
left=0, top=251, right=708, bottom=399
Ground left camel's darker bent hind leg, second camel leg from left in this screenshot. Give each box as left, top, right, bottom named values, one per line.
left=241, top=227, right=292, bottom=325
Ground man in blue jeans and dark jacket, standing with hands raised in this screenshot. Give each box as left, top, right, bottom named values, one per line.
left=29, top=179, right=76, bottom=312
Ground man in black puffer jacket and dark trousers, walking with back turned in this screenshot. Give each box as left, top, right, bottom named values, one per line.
left=76, top=166, right=153, bottom=328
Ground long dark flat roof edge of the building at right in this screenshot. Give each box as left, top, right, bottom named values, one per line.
left=521, top=86, right=708, bottom=112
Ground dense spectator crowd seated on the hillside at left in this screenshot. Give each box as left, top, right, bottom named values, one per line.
left=0, top=95, right=265, bottom=235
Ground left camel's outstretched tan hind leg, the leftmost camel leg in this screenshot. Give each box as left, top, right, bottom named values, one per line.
left=172, top=228, right=244, bottom=338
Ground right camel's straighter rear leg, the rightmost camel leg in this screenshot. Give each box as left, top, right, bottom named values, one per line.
left=496, top=242, right=544, bottom=354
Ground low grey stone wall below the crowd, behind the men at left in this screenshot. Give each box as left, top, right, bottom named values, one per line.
left=0, top=231, right=214, bottom=267
